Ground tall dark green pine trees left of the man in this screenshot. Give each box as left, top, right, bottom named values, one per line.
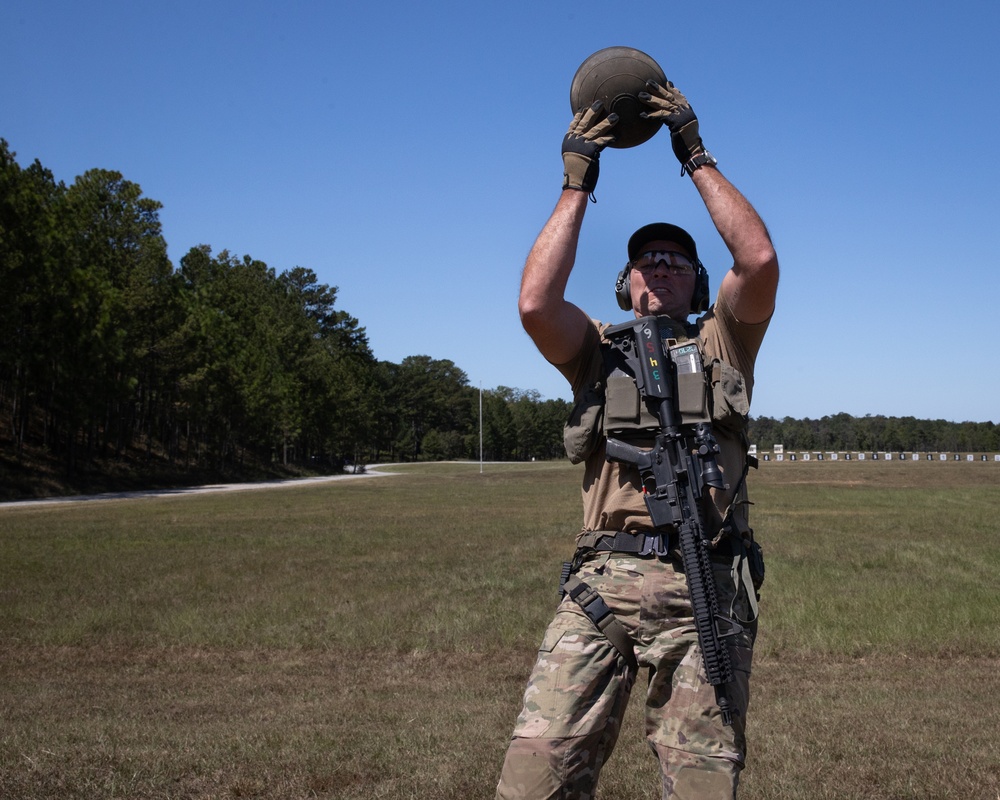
left=0, top=139, right=568, bottom=482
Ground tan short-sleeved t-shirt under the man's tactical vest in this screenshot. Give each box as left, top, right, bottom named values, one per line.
left=556, top=296, right=769, bottom=535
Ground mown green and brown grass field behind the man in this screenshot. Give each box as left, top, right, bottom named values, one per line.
left=0, top=462, right=1000, bottom=800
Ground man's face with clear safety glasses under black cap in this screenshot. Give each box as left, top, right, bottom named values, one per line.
left=629, top=241, right=695, bottom=320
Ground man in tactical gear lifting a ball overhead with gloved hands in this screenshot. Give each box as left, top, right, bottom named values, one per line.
left=497, top=82, right=778, bottom=798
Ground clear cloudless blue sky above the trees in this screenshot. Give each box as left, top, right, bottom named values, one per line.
left=0, top=0, right=1000, bottom=422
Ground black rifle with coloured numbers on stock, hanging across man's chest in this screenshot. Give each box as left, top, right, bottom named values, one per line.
left=604, top=317, right=742, bottom=725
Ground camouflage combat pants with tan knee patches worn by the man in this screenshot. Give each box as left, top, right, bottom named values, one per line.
left=497, top=554, right=756, bottom=800
